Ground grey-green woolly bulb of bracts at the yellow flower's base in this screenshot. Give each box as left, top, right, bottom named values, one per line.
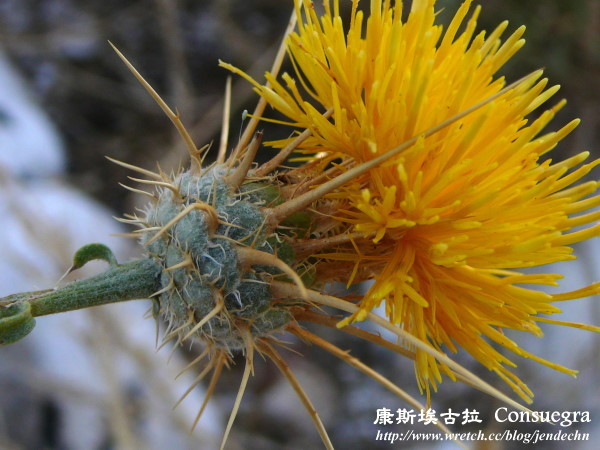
left=141, top=165, right=300, bottom=350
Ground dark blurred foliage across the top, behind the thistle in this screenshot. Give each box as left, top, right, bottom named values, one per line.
left=0, top=0, right=600, bottom=211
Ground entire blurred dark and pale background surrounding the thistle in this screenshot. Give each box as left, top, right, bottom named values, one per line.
left=0, top=0, right=600, bottom=449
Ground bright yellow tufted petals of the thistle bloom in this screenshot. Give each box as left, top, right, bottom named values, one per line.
left=223, top=0, right=600, bottom=400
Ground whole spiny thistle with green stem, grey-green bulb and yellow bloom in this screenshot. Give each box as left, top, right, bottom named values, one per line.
left=0, top=0, right=600, bottom=448
